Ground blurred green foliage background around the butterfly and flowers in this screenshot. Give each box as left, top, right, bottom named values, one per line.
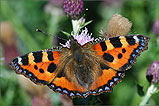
left=0, top=0, right=159, bottom=106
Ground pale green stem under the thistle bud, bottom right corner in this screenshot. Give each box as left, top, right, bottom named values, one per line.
left=139, top=84, right=157, bottom=106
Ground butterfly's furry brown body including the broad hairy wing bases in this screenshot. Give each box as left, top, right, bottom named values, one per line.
left=58, top=38, right=102, bottom=90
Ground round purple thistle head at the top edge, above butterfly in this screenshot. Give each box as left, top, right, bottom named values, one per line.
left=63, top=0, right=84, bottom=19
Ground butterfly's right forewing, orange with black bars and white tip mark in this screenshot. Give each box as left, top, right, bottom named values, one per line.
left=93, top=35, right=149, bottom=71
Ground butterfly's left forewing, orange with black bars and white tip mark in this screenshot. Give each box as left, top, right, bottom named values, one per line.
left=10, top=49, right=60, bottom=84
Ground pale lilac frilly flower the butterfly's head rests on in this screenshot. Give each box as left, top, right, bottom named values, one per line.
left=60, top=28, right=94, bottom=48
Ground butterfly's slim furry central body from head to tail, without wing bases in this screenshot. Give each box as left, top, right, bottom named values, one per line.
left=70, top=37, right=100, bottom=89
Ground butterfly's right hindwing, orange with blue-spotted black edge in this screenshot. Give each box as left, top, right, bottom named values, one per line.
left=90, top=67, right=125, bottom=95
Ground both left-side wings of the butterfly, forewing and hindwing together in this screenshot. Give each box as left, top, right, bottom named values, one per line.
left=10, top=49, right=86, bottom=97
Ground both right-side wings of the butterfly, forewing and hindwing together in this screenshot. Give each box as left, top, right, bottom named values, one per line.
left=86, top=35, right=149, bottom=95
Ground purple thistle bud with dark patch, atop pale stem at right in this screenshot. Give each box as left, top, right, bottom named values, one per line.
left=146, top=61, right=159, bottom=84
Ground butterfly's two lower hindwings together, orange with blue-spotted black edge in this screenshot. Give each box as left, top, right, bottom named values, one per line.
left=48, top=69, right=125, bottom=98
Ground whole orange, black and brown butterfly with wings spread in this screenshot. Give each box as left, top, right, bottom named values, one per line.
left=10, top=35, right=150, bottom=98
